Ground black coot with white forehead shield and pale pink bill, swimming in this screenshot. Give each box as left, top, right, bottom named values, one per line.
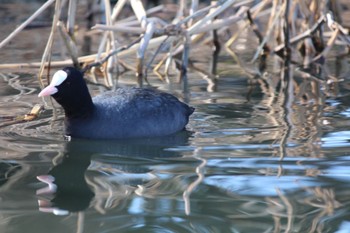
left=39, top=67, right=194, bottom=139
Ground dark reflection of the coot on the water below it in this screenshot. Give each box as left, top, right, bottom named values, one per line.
left=37, top=131, right=191, bottom=215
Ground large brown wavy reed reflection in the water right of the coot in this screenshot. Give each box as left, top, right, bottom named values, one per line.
left=223, top=44, right=347, bottom=158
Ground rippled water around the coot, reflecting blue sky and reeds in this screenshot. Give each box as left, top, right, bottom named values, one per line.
left=0, top=55, right=350, bottom=232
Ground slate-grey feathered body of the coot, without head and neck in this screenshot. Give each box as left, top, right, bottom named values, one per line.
left=67, top=88, right=194, bottom=139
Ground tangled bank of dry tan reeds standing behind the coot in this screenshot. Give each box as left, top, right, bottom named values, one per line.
left=0, top=0, right=350, bottom=86
